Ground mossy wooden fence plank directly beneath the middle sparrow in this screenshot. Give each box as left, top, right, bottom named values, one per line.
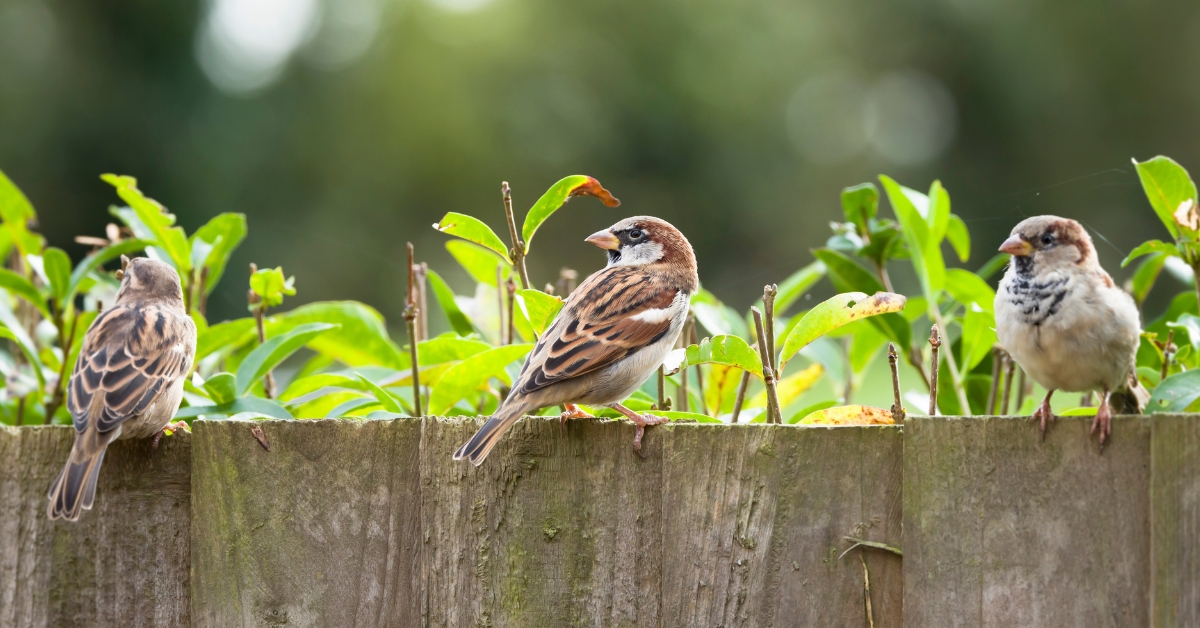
left=421, top=418, right=662, bottom=628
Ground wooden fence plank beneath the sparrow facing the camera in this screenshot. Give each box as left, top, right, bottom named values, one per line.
left=904, top=417, right=1151, bottom=627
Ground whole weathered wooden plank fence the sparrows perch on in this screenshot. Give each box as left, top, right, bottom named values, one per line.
left=0, top=415, right=1200, bottom=628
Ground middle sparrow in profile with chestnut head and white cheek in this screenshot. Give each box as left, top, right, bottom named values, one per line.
left=454, top=216, right=700, bottom=466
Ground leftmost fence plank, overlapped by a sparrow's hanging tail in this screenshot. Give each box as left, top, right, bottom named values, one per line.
left=0, top=426, right=192, bottom=628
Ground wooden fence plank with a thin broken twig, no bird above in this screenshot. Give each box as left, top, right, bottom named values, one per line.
left=662, top=425, right=901, bottom=626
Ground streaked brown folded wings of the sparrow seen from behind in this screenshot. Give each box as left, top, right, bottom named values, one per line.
left=67, top=305, right=196, bottom=432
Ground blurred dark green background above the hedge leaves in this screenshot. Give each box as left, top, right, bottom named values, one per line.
left=0, top=0, right=1200, bottom=331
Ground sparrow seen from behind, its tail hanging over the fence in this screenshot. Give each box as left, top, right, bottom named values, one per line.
left=47, top=256, right=196, bottom=521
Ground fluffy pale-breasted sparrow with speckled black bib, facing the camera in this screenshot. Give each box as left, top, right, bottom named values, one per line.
left=996, top=216, right=1150, bottom=447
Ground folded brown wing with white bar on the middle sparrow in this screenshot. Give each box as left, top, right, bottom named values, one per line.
left=514, top=267, right=679, bottom=394
